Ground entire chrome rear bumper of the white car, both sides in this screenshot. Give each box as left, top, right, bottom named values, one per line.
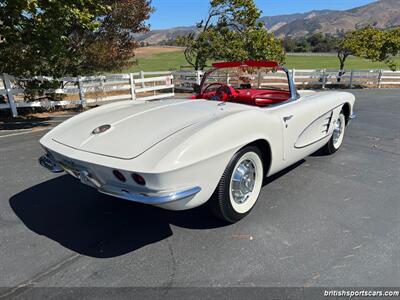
left=39, top=154, right=201, bottom=205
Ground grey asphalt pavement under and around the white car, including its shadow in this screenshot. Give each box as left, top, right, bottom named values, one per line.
left=0, top=90, right=400, bottom=293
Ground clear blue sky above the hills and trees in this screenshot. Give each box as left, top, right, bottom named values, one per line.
left=149, top=0, right=374, bottom=29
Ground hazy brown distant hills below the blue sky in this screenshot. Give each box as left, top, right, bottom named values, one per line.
left=136, top=0, right=400, bottom=44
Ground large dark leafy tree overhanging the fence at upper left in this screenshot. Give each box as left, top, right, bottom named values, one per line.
left=0, top=0, right=152, bottom=77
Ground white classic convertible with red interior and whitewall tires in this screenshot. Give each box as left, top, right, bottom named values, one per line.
left=39, top=61, right=355, bottom=222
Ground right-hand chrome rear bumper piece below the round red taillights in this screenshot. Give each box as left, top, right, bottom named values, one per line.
left=98, top=185, right=201, bottom=204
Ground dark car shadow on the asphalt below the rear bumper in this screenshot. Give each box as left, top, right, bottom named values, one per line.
left=10, top=175, right=226, bottom=258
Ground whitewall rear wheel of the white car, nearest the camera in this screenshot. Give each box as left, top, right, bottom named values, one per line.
left=209, top=146, right=264, bottom=223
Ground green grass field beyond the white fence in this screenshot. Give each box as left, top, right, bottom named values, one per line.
left=124, top=52, right=400, bottom=72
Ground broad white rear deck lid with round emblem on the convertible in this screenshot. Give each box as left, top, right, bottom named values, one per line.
left=52, top=100, right=236, bottom=159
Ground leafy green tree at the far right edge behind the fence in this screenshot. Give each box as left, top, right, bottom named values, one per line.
left=337, top=26, right=400, bottom=70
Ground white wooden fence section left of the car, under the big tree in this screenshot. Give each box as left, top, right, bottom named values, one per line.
left=0, top=72, right=175, bottom=117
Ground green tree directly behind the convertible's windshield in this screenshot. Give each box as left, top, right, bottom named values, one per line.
left=179, top=0, right=285, bottom=70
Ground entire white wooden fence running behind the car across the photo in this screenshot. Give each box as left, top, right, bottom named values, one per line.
left=0, top=69, right=400, bottom=117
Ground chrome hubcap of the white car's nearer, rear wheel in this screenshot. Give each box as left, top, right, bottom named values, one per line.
left=231, top=159, right=256, bottom=204
